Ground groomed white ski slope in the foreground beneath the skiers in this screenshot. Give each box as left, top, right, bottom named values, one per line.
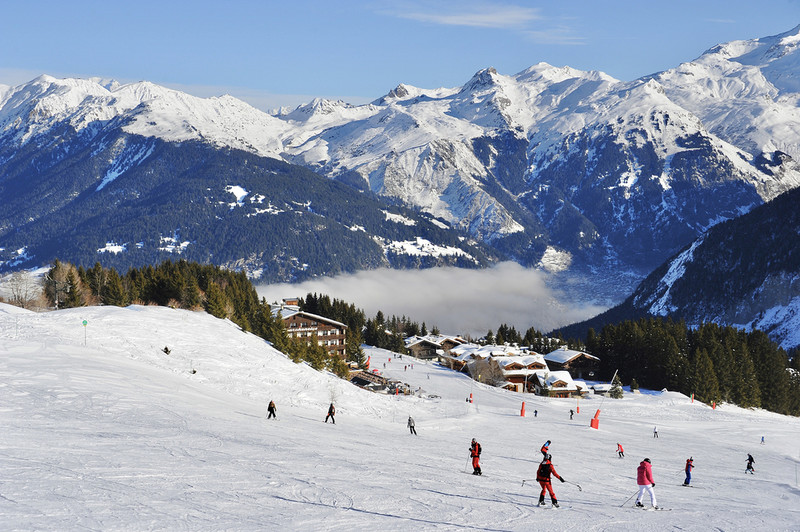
left=0, top=304, right=800, bottom=531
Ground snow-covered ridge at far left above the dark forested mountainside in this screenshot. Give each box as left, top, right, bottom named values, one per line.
left=0, top=75, right=288, bottom=157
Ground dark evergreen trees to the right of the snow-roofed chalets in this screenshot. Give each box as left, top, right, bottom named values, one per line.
left=585, top=318, right=800, bottom=416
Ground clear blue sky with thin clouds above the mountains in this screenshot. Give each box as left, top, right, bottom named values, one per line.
left=0, top=0, right=800, bottom=109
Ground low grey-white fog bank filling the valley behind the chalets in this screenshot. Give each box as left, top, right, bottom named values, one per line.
left=257, top=262, right=606, bottom=337
